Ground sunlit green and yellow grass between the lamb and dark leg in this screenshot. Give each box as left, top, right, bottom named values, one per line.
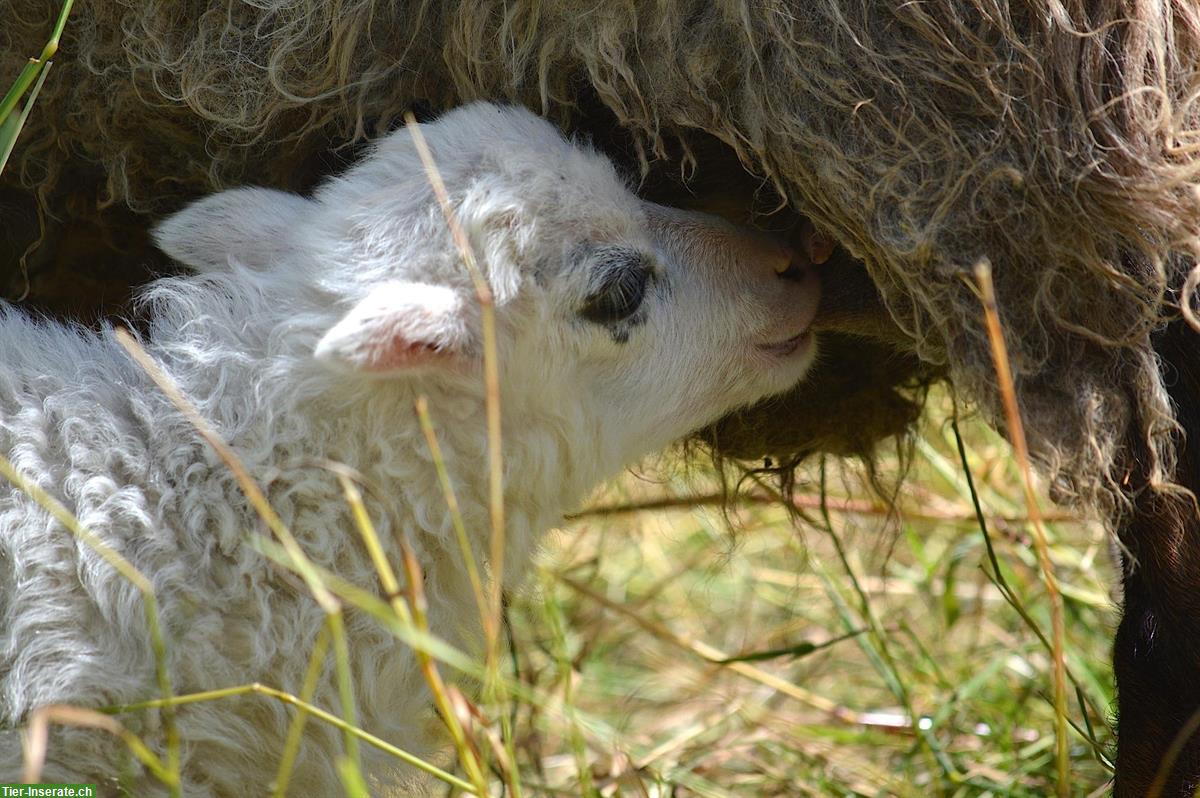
left=511, top=388, right=1116, bottom=796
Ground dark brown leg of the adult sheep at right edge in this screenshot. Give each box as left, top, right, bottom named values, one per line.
left=1114, top=323, right=1200, bottom=798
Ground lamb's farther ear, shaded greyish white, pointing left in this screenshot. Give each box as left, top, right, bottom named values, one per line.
left=154, top=188, right=314, bottom=272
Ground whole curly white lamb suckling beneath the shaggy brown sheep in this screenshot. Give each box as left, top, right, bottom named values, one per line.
left=0, top=103, right=817, bottom=796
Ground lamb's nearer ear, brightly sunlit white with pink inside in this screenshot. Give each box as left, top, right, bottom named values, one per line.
left=313, top=282, right=473, bottom=376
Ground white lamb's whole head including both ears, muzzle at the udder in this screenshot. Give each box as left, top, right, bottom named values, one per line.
left=158, top=103, right=817, bottom=469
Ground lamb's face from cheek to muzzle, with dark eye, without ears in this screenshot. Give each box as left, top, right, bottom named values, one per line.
left=499, top=190, right=818, bottom=457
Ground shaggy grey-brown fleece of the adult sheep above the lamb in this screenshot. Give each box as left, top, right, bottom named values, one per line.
left=7, top=0, right=1200, bottom=509
